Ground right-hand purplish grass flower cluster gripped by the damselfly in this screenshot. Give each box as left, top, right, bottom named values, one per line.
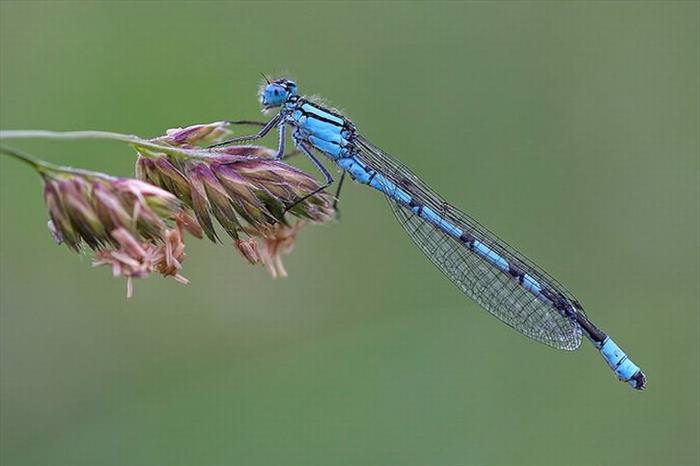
left=136, top=122, right=335, bottom=277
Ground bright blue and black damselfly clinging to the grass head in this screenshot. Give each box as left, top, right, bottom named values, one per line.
left=212, top=78, right=646, bottom=390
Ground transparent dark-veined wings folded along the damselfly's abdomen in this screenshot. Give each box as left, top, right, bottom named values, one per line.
left=357, top=136, right=583, bottom=351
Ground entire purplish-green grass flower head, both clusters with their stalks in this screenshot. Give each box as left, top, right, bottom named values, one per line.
left=0, top=121, right=335, bottom=296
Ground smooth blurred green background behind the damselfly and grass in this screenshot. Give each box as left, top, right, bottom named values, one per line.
left=0, top=0, right=700, bottom=465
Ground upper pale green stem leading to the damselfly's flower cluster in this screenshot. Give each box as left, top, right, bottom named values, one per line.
left=0, top=129, right=216, bottom=159
